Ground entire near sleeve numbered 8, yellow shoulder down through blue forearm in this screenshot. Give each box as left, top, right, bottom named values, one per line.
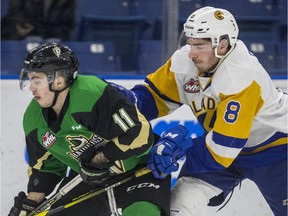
left=187, top=82, right=263, bottom=172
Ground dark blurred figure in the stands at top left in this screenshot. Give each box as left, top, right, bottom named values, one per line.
left=1, top=0, right=76, bottom=40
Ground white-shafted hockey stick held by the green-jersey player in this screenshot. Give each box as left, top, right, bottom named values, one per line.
left=28, top=175, right=83, bottom=216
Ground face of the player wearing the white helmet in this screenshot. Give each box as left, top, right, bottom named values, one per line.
left=187, top=38, right=219, bottom=72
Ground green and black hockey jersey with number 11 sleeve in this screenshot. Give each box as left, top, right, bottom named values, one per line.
left=23, top=75, right=153, bottom=192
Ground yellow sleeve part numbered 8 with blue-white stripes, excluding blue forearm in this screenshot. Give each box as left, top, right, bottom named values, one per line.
left=206, top=82, right=263, bottom=167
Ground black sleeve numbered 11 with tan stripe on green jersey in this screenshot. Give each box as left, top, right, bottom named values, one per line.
left=85, top=85, right=153, bottom=161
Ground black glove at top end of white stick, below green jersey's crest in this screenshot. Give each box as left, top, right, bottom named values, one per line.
left=80, top=148, right=114, bottom=185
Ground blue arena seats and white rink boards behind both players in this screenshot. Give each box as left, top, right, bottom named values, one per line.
left=0, top=0, right=287, bottom=216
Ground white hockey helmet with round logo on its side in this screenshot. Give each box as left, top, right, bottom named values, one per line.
left=184, top=6, right=239, bottom=47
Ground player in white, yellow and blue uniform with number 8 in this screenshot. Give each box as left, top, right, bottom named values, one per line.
left=111, top=7, right=288, bottom=216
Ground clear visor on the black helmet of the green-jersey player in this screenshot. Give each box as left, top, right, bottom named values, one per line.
left=19, top=68, right=55, bottom=91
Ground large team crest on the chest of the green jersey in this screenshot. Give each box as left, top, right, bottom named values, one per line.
left=66, top=134, right=106, bottom=160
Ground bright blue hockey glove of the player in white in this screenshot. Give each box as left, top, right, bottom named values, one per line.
left=147, top=125, right=193, bottom=178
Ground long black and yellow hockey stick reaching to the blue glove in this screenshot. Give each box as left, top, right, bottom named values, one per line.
left=35, top=167, right=151, bottom=216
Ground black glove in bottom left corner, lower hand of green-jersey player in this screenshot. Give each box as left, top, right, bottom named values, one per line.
left=8, top=191, right=40, bottom=216
